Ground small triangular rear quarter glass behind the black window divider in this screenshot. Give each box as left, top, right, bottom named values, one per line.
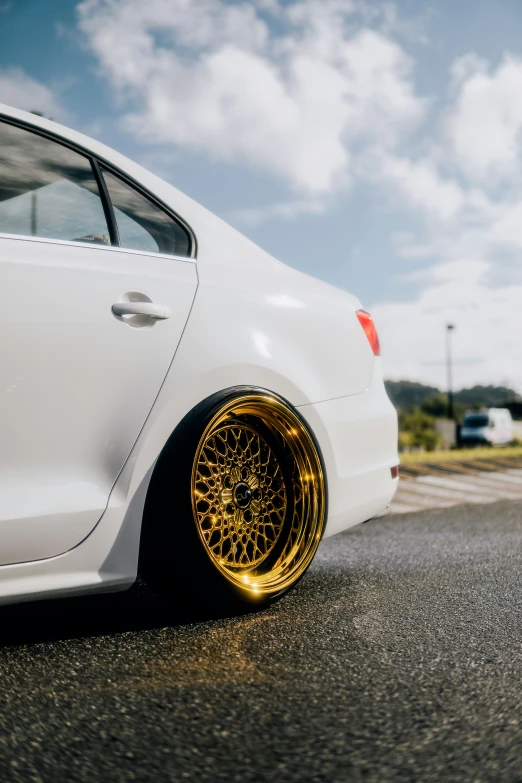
left=102, top=169, right=190, bottom=256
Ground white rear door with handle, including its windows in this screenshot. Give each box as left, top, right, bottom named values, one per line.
left=0, top=122, right=197, bottom=564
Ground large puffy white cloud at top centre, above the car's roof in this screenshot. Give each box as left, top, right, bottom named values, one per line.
left=78, top=0, right=427, bottom=194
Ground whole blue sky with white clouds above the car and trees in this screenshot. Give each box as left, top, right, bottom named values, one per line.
left=0, top=0, right=522, bottom=392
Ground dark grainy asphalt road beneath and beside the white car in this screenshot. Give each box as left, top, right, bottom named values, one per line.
left=0, top=501, right=522, bottom=783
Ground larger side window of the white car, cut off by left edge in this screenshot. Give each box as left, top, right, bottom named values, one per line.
left=0, top=122, right=111, bottom=245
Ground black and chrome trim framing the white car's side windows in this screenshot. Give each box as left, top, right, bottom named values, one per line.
left=0, top=111, right=198, bottom=261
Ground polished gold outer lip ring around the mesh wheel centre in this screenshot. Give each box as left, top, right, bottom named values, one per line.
left=191, top=392, right=326, bottom=599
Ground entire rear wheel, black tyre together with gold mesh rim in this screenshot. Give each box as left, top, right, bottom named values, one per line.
left=139, top=387, right=326, bottom=616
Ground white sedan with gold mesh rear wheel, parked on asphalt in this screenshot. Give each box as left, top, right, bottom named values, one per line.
left=0, top=106, right=398, bottom=612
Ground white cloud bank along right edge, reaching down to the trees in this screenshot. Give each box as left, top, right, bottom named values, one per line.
left=363, top=46, right=522, bottom=391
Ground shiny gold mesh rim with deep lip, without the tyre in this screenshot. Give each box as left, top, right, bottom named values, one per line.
left=192, top=394, right=325, bottom=596
